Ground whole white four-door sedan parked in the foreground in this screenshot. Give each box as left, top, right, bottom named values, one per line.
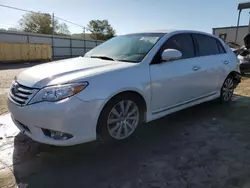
left=8, top=31, right=240, bottom=146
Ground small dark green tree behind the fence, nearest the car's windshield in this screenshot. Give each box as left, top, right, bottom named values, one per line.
left=88, top=20, right=115, bottom=40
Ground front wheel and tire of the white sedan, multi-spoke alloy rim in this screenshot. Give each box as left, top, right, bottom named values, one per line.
left=97, top=94, right=144, bottom=143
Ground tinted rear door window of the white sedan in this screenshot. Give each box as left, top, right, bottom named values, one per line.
left=194, top=34, right=220, bottom=56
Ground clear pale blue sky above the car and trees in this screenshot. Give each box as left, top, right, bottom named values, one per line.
left=0, top=0, right=250, bottom=35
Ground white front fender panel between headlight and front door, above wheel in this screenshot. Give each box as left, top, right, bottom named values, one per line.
left=76, top=63, right=150, bottom=106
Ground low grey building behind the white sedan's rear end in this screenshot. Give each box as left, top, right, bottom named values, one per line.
left=213, top=25, right=248, bottom=46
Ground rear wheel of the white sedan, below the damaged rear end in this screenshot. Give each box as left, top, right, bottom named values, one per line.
left=220, top=76, right=235, bottom=103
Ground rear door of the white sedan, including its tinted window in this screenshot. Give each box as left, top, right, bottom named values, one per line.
left=193, top=34, right=230, bottom=95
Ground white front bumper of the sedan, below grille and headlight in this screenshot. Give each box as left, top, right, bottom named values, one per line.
left=8, top=96, right=103, bottom=146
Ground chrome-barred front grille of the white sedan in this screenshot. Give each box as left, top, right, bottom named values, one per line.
left=9, top=82, right=38, bottom=106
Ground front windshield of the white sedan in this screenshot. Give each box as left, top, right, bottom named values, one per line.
left=85, top=33, right=164, bottom=62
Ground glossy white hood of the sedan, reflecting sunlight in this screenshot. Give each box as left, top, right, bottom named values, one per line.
left=16, top=57, right=135, bottom=88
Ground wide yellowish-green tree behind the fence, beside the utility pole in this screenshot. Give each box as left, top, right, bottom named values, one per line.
left=19, top=13, right=70, bottom=35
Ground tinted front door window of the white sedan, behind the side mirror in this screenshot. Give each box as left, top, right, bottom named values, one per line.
left=162, top=34, right=195, bottom=59
